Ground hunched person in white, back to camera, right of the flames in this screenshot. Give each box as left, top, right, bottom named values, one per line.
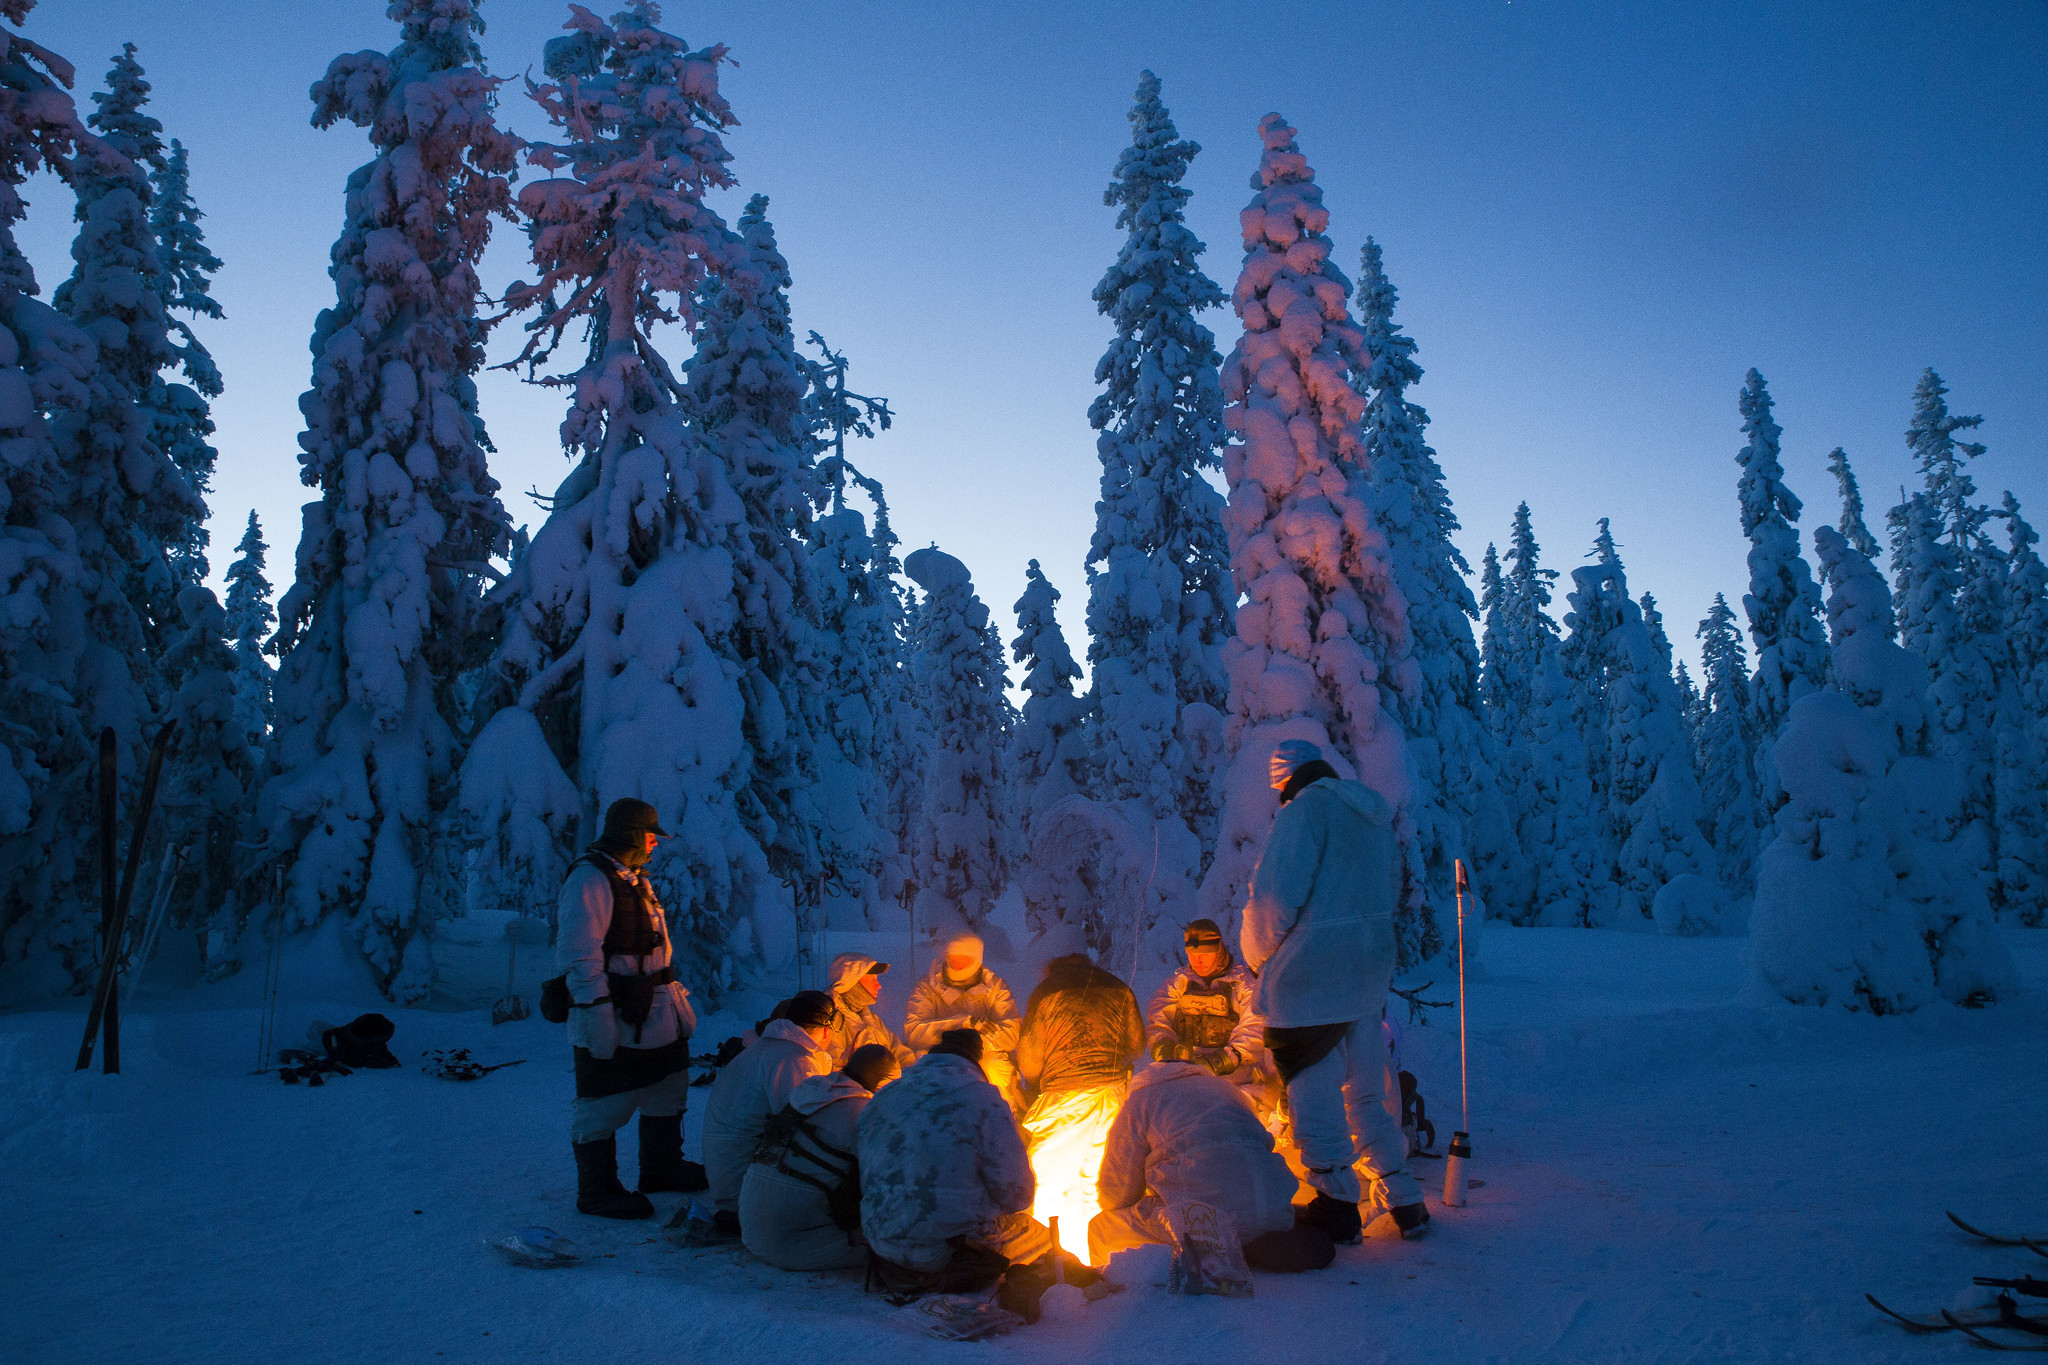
left=1087, top=1062, right=1337, bottom=1271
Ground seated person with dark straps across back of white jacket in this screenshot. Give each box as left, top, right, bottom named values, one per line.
left=739, top=1044, right=903, bottom=1271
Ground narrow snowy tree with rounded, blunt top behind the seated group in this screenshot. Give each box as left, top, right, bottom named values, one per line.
left=903, top=546, right=1012, bottom=935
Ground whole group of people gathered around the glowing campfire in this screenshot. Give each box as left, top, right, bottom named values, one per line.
left=557, top=741, right=1430, bottom=1320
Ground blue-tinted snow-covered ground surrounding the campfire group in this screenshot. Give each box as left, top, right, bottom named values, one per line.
left=0, top=925, right=2048, bottom=1365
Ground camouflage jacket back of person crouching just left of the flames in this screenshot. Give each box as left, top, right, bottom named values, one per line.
left=856, top=1052, right=1036, bottom=1271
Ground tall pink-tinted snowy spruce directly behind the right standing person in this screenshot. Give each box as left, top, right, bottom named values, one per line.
left=1200, top=115, right=1442, bottom=964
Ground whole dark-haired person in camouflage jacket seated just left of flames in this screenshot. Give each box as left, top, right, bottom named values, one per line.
left=856, top=1029, right=1081, bottom=1318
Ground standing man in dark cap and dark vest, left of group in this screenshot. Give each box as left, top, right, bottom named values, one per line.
left=555, top=796, right=705, bottom=1218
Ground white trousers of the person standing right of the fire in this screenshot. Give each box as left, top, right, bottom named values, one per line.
left=1286, top=1019, right=1421, bottom=1207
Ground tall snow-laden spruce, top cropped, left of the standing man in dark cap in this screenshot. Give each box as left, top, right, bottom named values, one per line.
left=260, top=0, right=520, bottom=1001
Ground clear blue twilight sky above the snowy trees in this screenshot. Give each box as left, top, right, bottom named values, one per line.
left=8, top=0, right=2048, bottom=683
